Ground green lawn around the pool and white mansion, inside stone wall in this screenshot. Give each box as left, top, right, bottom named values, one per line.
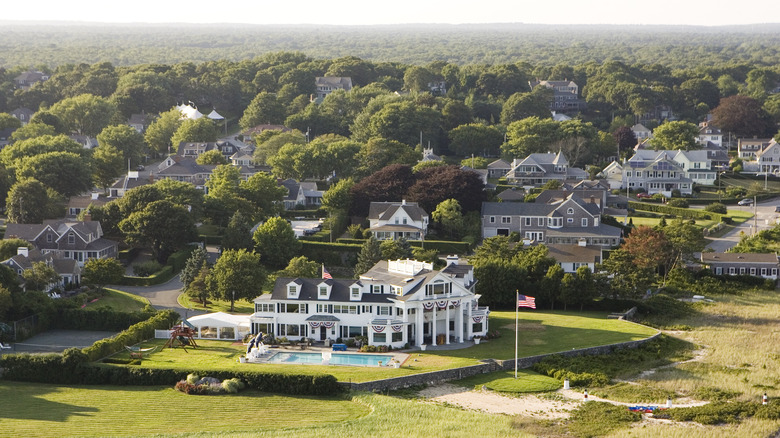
left=116, top=311, right=656, bottom=382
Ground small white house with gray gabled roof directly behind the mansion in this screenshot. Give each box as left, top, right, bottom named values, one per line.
left=368, top=200, right=429, bottom=240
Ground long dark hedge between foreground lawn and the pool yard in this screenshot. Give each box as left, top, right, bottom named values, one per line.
left=0, top=348, right=343, bottom=395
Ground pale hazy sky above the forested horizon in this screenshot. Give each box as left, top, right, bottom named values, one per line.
left=0, top=0, right=780, bottom=26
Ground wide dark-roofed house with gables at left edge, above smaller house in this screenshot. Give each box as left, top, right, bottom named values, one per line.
left=4, top=219, right=118, bottom=266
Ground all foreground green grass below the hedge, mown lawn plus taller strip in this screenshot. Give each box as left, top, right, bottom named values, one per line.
left=0, top=381, right=529, bottom=438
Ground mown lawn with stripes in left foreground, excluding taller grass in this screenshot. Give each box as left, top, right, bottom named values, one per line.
left=0, top=381, right=370, bottom=437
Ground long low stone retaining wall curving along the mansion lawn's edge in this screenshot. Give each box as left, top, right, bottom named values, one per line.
left=339, top=332, right=661, bottom=391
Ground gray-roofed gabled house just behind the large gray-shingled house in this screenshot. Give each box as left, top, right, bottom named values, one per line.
left=506, top=152, right=588, bottom=186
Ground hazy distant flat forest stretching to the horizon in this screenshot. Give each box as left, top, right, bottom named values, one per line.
left=0, top=22, right=780, bottom=68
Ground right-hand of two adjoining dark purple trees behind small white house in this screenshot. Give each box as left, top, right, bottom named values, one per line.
left=406, top=166, right=485, bottom=212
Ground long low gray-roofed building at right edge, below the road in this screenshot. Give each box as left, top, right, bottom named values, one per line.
left=701, top=252, right=780, bottom=280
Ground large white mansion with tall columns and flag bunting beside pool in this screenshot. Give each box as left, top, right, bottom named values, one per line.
left=251, top=258, right=490, bottom=348
